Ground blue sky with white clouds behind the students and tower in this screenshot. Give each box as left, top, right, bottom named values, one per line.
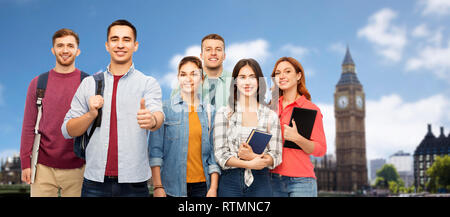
left=0, top=0, right=450, bottom=170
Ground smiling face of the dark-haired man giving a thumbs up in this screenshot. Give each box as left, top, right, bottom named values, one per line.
left=105, top=25, right=138, bottom=64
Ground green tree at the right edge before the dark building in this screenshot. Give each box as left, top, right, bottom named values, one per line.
left=427, top=155, right=450, bottom=193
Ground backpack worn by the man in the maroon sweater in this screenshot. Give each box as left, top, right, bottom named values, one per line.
left=31, top=71, right=89, bottom=183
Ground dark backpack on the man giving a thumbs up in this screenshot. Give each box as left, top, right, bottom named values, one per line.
left=73, top=72, right=105, bottom=159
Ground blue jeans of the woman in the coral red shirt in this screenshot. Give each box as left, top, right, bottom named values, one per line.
left=270, top=173, right=317, bottom=197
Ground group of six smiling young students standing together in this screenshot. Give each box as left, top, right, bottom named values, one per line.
left=20, top=20, right=326, bottom=197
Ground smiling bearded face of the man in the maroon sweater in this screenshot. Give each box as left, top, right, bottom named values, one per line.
left=51, top=35, right=80, bottom=66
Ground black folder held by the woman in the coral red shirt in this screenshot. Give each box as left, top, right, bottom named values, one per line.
left=283, top=107, right=317, bottom=149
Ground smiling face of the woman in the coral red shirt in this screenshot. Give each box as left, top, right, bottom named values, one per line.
left=275, top=61, right=302, bottom=91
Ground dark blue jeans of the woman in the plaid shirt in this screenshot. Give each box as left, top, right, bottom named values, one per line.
left=217, top=168, right=272, bottom=197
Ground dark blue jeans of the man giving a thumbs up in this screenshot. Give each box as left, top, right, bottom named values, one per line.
left=81, top=177, right=150, bottom=197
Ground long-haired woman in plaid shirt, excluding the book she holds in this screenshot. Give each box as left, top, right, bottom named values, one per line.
left=214, top=59, right=282, bottom=197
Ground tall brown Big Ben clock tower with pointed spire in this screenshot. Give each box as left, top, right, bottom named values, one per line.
left=334, top=47, right=368, bottom=191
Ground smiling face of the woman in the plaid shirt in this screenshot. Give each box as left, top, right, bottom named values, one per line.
left=236, top=65, right=258, bottom=97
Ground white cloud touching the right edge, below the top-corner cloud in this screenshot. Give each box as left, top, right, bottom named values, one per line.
left=405, top=40, right=450, bottom=83
